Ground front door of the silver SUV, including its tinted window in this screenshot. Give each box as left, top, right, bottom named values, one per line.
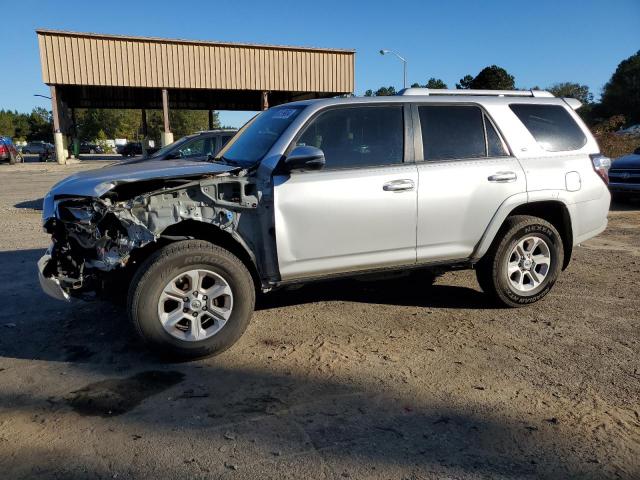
left=274, top=104, right=418, bottom=280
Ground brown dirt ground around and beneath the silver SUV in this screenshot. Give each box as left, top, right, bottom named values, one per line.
left=0, top=162, right=640, bottom=479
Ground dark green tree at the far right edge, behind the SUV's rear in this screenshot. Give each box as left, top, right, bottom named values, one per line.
left=598, top=50, right=640, bottom=124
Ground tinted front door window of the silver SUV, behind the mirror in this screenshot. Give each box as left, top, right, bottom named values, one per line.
left=296, top=106, right=404, bottom=168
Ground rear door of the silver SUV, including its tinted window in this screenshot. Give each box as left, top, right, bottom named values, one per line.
left=413, top=104, right=526, bottom=262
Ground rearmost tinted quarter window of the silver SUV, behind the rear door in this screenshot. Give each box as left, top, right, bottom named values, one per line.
left=509, top=103, right=587, bottom=152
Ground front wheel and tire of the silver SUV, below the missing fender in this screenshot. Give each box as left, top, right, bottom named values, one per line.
left=127, top=240, right=256, bottom=360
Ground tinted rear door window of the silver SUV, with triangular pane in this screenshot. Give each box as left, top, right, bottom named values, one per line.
left=418, top=105, right=508, bottom=161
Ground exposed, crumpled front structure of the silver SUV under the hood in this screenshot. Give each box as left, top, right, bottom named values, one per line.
left=42, top=171, right=262, bottom=296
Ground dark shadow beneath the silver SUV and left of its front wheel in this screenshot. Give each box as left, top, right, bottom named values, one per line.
left=0, top=249, right=496, bottom=371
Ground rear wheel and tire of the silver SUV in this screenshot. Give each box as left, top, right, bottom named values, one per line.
left=476, top=215, right=564, bottom=307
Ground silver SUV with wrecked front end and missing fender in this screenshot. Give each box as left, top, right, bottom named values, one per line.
left=39, top=89, right=610, bottom=358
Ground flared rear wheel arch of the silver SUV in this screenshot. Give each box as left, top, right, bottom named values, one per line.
left=472, top=200, right=573, bottom=270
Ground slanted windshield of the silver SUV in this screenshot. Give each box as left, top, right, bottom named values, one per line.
left=216, top=106, right=304, bottom=167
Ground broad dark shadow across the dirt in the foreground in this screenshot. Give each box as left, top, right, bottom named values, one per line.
left=0, top=365, right=612, bottom=479
